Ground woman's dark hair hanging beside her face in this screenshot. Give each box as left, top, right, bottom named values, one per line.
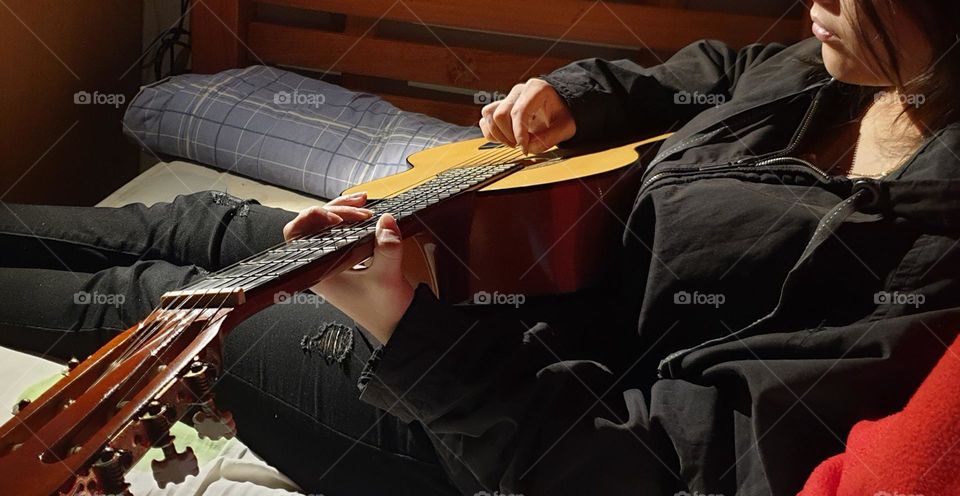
left=856, top=0, right=960, bottom=135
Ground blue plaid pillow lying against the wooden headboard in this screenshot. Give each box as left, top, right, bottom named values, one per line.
left=124, top=66, right=481, bottom=198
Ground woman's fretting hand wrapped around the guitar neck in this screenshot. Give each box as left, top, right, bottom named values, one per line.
left=283, top=193, right=413, bottom=343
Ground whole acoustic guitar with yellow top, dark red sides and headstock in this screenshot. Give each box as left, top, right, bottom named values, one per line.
left=0, top=136, right=666, bottom=495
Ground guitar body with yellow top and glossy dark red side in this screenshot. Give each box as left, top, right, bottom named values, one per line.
left=344, top=136, right=666, bottom=303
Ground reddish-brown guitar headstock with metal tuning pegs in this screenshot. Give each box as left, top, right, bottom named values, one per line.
left=0, top=305, right=234, bottom=495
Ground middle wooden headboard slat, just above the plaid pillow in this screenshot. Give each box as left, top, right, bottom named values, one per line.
left=248, top=22, right=570, bottom=92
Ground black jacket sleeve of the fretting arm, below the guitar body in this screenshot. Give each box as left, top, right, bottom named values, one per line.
left=360, top=285, right=664, bottom=495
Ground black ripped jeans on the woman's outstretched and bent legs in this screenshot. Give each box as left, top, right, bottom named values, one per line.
left=0, top=192, right=456, bottom=496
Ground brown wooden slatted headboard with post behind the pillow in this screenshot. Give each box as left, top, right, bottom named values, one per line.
left=191, top=0, right=809, bottom=124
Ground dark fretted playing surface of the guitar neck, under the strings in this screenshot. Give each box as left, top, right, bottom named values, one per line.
left=162, top=163, right=520, bottom=305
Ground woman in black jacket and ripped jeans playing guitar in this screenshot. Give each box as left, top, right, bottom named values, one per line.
left=2, top=0, right=960, bottom=495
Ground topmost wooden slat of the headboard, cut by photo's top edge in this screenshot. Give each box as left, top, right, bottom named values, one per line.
left=259, top=0, right=802, bottom=51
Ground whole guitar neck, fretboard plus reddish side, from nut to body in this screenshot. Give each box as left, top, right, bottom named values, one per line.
left=161, top=163, right=522, bottom=308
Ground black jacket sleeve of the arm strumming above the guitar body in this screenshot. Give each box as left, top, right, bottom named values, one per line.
left=541, top=40, right=785, bottom=146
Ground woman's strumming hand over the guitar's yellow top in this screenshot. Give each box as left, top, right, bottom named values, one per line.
left=480, top=79, right=577, bottom=153
